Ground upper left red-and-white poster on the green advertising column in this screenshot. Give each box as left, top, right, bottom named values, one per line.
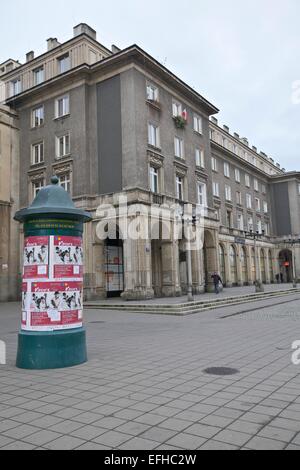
left=23, top=237, right=49, bottom=279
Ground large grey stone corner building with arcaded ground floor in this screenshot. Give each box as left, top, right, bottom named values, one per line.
left=1, top=24, right=300, bottom=299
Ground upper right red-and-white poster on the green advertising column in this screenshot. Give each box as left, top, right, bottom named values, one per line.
left=52, top=236, right=83, bottom=279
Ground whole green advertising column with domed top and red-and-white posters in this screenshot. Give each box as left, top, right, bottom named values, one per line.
left=15, top=176, right=91, bottom=370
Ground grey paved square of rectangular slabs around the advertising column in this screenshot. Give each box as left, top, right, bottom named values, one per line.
left=0, top=293, right=300, bottom=450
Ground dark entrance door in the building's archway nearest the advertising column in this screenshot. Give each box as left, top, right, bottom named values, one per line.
left=105, top=240, right=124, bottom=297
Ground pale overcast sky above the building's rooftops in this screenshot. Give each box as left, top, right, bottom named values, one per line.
left=0, top=0, right=300, bottom=170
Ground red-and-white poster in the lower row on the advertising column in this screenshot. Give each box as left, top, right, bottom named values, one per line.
left=24, top=282, right=83, bottom=331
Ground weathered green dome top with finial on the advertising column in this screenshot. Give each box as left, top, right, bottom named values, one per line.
left=15, top=176, right=92, bottom=222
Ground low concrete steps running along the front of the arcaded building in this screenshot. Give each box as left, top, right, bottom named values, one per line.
left=85, top=288, right=300, bottom=316
